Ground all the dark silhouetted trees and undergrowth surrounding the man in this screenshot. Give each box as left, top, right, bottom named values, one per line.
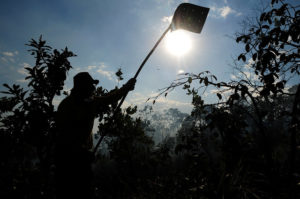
left=0, top=0, right=300, bottom=199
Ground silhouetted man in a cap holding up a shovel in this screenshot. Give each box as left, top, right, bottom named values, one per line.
left=56, top=72, right=136, bottom=199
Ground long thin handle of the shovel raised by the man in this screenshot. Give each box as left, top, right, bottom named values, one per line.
left=94, top=23, right=172, bottom=154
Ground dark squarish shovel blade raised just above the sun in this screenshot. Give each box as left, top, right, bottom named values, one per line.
left=172, top=3, right=209, bottom=33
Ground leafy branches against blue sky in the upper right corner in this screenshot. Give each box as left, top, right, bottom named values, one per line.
left=236, top=1, right=300, bottom=96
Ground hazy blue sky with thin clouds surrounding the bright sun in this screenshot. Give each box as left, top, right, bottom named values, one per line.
left=0, top=0, right=290, bottom=112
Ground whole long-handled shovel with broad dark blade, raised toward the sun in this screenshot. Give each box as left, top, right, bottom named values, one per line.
left=94, top=3, right=209, bottom=153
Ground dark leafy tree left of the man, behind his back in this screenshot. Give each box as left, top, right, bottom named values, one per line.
left=0, top=36, right=75, bottom=198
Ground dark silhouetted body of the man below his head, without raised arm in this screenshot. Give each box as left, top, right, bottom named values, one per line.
left=56, top=95, right=94, bottom=198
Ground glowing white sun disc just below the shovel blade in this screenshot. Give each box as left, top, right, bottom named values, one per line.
left=166, top=30, right=192, bottom=57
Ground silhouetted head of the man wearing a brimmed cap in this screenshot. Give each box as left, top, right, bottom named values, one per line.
left=72, top=72, right=99, bottom=97
